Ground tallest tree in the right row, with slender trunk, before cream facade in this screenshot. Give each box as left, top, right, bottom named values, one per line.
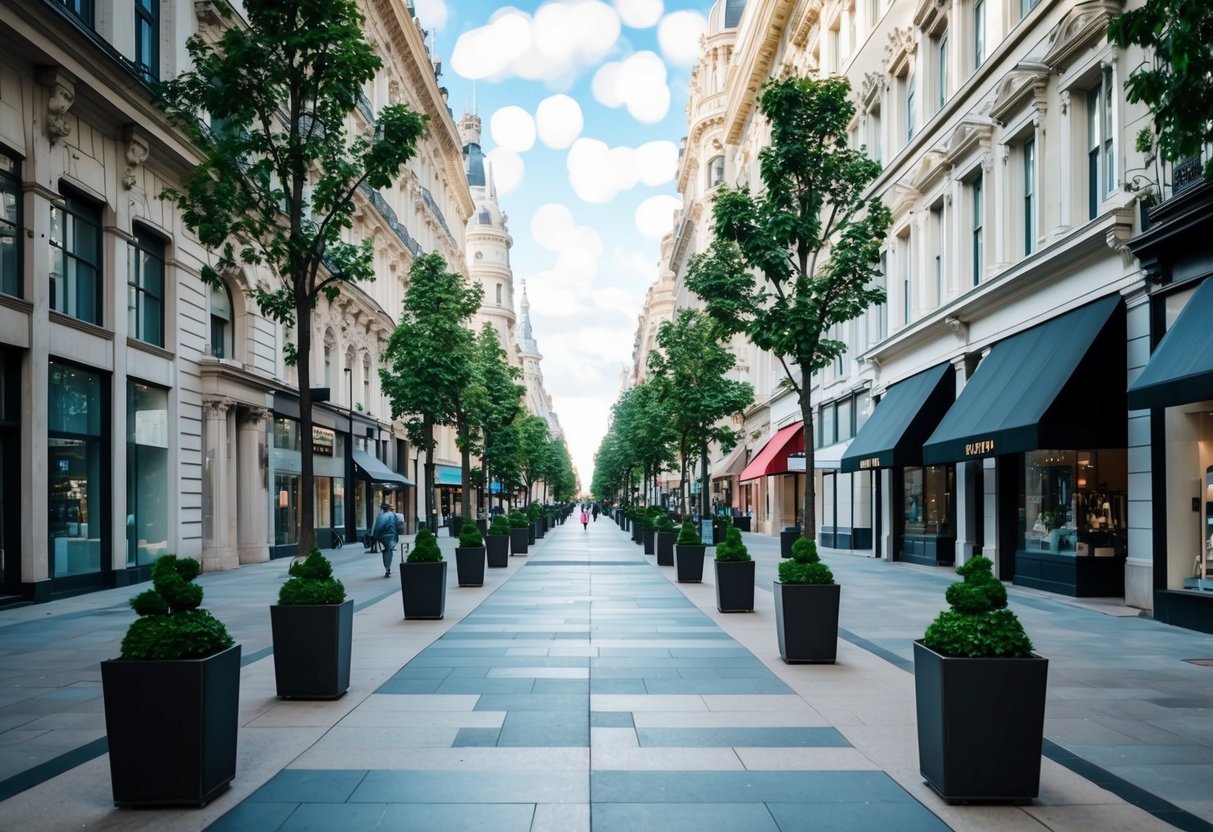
left=687, top=76, right=890, bottom=537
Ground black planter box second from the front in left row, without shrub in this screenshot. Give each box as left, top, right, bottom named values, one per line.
left=269, top=598, right=354, bottom=699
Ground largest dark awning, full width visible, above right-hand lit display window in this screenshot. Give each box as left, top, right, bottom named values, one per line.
left=922, top=295, right=1128, bottom=465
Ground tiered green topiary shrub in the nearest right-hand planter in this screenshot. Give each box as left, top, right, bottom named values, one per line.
left=922, top=555, right=1032, bottom=659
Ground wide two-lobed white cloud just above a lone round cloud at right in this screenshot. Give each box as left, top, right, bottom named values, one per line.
left=565, top=138, right=678, bottom=204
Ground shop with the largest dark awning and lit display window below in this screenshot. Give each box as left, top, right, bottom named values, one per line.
left=921, top=295, right=1128, bottom=597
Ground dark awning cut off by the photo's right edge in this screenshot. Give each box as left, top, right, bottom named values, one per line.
left=1129, top=279, right=1213, bottom=410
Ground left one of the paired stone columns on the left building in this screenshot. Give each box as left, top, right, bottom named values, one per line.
left=203, top=399, right=240, bottom=572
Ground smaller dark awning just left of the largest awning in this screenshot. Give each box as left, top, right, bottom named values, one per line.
left=841, top=363, right=956, bottom=472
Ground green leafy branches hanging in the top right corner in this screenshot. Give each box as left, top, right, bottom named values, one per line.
left=1107, top=0, right=1213, bottom=178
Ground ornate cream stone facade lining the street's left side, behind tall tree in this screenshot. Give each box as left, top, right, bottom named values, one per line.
left=0, top=0, right=473, bottom=600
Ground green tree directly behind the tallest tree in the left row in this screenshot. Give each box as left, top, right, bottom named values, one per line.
left=380, top=252, right=482, bottom=528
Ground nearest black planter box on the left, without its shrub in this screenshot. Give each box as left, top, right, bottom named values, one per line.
left=101, top=644, right=240, bottom=807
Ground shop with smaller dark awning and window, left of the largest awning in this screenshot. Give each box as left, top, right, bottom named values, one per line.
left=839, top=363, right=956, bottom=566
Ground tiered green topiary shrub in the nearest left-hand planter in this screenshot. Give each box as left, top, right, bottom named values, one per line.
left=121, top=554, right=235, bottom=661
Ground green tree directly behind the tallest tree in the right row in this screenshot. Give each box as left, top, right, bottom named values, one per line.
left=649, top=309, right=754, bottom=515
